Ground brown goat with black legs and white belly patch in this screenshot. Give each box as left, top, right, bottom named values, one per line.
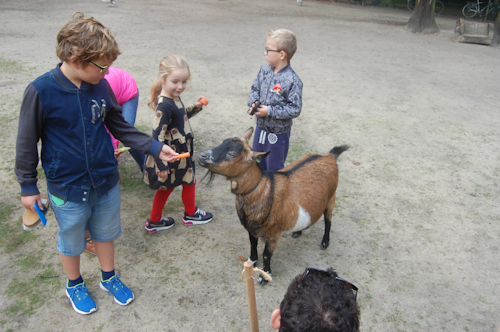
left=198, top=128, right=349, bottom=283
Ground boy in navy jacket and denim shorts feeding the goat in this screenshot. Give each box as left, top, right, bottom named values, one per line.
left=15, top=12, right=177, bottom=315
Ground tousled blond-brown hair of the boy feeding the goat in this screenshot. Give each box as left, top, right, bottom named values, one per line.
left=56, top=12, right=121, bottom=68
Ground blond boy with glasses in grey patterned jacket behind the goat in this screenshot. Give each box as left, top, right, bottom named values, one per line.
left=248, top=29, right=302, bottom=171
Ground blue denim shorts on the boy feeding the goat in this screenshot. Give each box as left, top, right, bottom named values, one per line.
left=49, top=184, right=122, bottom=257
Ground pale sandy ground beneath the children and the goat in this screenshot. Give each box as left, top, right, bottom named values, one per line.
left=0, top=0, right=500, bottom=332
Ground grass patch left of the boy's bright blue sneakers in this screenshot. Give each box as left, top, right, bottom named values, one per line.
left=3, top=268, right=60, bottom=316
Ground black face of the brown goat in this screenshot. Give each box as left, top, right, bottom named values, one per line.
left=198, top=137, right=243, bottom=173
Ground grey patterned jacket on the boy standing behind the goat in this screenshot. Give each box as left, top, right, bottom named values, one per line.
left=248, top=64, right=302, bottom=134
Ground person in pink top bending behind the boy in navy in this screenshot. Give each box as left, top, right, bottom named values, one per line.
left=104, top=67, right=145, bottom=171
